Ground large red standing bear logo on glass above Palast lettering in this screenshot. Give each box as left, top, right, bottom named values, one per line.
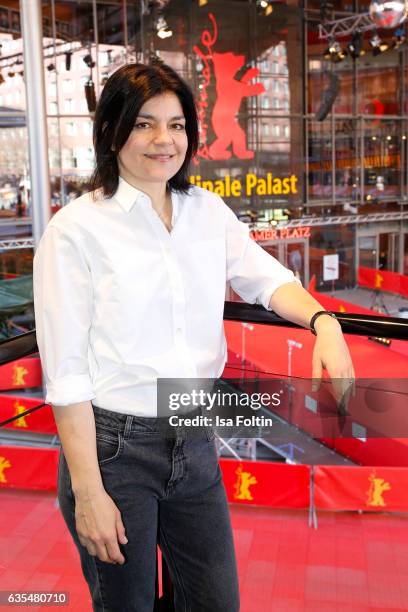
left=209, top=53, right=265, bottom=159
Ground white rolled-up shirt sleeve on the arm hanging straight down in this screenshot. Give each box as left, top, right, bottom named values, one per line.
left=33, top=224, right=95, bottom=406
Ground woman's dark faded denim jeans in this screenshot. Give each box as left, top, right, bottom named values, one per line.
left=58, top=406, right=239, bottom=612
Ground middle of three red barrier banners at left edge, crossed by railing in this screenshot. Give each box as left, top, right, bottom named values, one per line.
left=0, top=394, right=57, bottom=434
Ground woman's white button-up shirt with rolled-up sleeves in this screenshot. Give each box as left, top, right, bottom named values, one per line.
left=33, top=178, right=302, bottom=417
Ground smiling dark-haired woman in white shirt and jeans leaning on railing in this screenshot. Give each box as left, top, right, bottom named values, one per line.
left=34, top=64, right=354, bottom=612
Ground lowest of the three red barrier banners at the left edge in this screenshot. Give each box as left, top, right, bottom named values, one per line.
left=0, top=446, right=59, bottom=490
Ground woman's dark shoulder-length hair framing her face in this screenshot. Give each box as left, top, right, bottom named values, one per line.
left=90, top=63, right=199, bottom=198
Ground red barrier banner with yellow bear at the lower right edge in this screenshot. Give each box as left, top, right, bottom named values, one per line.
left=314, top=465, right=408, bottom=512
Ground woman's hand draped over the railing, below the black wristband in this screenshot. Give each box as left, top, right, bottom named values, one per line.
left=312, top=317, right=355, bottom=411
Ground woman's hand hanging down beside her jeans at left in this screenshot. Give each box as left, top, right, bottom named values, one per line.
left=75, top=488, right=128, bottom=565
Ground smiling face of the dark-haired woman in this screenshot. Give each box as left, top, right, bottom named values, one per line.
left=118, top=92, right=188, bottom=187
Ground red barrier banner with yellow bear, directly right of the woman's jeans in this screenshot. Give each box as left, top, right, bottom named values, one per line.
left=220, top=459, right=310, bottom=508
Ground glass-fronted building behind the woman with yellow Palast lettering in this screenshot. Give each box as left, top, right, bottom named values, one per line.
left=0, top=0, right=408, bottom=290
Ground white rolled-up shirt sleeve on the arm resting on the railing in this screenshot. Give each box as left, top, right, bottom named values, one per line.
left=225, top=205, right=301, bottom=310
